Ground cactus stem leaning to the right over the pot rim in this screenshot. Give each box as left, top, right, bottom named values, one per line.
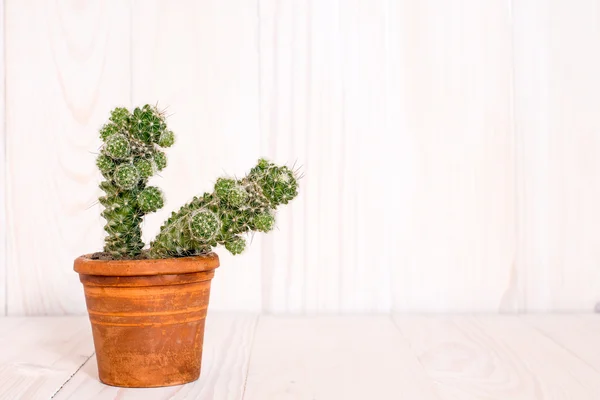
left=150, top=159, right=298, bottom=258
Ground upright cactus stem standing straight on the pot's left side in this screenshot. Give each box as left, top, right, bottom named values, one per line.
left=96, top=105, right=175, bottom=259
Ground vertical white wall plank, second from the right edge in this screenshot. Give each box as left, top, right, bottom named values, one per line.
left=386, top=0, right=518, bottom=312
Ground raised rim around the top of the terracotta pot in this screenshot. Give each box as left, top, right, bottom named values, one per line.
left=73, top=253, right=219, bottom=276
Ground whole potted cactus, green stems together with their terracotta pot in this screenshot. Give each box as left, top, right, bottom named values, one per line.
left=74, top=105, right=298, bottom=387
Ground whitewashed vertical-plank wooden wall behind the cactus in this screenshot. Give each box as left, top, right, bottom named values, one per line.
left=0, top=0, right=600, bottom=315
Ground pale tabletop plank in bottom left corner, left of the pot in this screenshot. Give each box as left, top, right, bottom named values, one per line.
left=0, top=317, right=94, bottom=399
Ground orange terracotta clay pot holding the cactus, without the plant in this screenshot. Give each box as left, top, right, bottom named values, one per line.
left=74, top=253, right=219, bottom=387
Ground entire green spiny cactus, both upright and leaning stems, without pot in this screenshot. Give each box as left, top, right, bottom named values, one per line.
left=96, top=105, right=298, bottom=259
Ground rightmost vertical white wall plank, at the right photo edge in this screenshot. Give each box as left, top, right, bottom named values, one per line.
left=513, top=0, right=600, bottom=312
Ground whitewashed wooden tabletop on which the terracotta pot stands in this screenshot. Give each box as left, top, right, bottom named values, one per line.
left=0, top=313, right=600, bottom=400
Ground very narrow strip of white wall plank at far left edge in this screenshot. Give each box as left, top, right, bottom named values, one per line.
left=0, top=0, right=8, bottom=316
